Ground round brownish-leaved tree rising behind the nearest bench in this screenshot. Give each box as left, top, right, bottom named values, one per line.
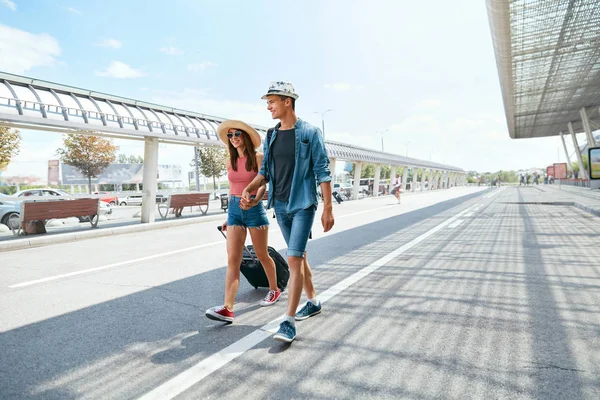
left=56, top=133, right=119, bottom=193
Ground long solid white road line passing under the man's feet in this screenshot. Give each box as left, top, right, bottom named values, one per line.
left=140, top=208, right=471, bottom=400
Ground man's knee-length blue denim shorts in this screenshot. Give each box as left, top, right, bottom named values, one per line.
left=274, top=200, right=317, bottom=257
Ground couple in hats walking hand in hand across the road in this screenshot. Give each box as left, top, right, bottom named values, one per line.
left=206, top=82, right=334, bottom=343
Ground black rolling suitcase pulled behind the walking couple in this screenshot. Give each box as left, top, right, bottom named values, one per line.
left=217, top=225, right=290, bottom=292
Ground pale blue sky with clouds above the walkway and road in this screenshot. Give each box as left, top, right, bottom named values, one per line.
left=0, top=0, right=584, bottom=183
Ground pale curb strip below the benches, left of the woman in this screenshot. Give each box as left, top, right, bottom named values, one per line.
left=0, top=213, right=227, bottom=253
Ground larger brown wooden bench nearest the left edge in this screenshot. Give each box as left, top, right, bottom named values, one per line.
left=13, top=198, right=100, bottom=235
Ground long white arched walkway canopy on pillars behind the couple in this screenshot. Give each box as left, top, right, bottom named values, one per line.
left=0, top=72, right=466, bottom=222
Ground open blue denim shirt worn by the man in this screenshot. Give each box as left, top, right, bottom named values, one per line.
left=258, top=118, right=331, bottom=213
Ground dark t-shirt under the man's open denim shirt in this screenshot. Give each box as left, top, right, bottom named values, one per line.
left=271, top=129, right=296, bottom=202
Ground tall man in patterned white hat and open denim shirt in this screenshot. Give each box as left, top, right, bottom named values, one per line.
left=242, top=82, right=334, bottom=343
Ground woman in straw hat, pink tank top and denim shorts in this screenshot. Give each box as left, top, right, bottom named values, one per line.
left=206, top=121, right=281, bottom=322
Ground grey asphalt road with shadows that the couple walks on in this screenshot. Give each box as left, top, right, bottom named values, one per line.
left=0, top=188, right=600, bottom=399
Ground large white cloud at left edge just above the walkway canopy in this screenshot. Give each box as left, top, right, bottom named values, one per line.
left=0, top=25, right=61, bottom=74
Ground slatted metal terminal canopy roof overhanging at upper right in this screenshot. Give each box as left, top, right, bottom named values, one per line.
left=487, top=0, right=600, bottom=139
